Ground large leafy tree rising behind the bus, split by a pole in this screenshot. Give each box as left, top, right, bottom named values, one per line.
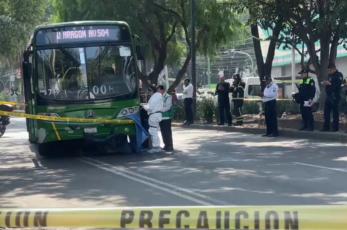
left=54, top=0, right=239, bottom=88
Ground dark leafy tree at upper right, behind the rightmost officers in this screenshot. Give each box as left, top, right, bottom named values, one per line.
left=277, top=0, right=347, bottom=80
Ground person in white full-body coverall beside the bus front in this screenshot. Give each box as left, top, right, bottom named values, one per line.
left=143, top=85, right=165, bottom=153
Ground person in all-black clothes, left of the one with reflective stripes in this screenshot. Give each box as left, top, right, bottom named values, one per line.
left=215, top=71, right=232, bottom=126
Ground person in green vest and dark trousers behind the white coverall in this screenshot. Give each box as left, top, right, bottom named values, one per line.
left=159, top=89, right=174, bottom=152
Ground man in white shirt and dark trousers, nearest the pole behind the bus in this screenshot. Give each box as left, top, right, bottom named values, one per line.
left=183, top=79, right=194, bottom=125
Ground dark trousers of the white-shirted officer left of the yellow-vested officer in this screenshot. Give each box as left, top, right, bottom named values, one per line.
left=264, top=100, right=278, bottom=135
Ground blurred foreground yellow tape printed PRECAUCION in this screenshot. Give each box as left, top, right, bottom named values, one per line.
left=0, top=205, right=347, bottom=230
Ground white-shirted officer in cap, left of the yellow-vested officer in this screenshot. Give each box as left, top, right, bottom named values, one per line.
left=263, top=76, right=278, bottom=137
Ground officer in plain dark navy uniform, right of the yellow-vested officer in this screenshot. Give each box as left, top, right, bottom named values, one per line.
left=322, top=64, right=343, bottom=132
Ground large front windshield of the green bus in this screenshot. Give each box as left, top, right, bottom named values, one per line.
left=37, top=46, right=137, bottom=101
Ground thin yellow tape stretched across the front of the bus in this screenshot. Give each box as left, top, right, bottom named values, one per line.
left=0, top=110, right=135, bottom=125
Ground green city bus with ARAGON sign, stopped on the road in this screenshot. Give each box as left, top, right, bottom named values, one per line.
left=22, top=21, right=140, bottom=154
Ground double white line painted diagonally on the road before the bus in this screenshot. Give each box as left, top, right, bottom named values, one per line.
left=80, top=157, right=225, bottom=205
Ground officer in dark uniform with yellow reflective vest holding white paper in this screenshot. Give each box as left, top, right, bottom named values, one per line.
left=299, top=68, right=316, bottom=131
